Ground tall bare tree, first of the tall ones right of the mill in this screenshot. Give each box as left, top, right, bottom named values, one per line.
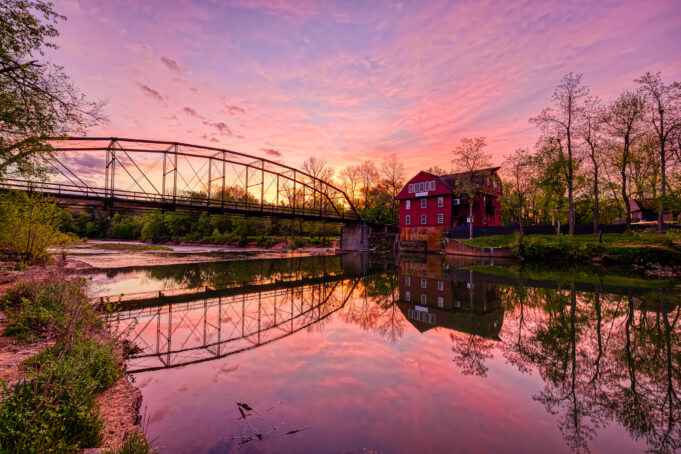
left=530, top=73, right=589, bottom=235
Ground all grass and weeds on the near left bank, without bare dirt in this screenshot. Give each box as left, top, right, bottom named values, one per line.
left=0, top=272, right=146, bottom=453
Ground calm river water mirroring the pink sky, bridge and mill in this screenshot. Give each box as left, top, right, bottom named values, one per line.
left=86, top=255, right=681, bottom=454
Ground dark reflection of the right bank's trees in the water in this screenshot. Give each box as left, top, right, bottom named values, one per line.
left=500, top=284, right=681, bottom=452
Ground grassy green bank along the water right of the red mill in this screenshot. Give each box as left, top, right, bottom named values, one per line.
left=460, top=231, right=681, bottom=265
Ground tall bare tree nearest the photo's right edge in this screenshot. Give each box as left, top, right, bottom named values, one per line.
left=635, top=72, right=681, bottom=233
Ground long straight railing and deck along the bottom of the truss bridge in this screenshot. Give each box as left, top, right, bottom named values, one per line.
left=0, top=179, right=359, bottom=220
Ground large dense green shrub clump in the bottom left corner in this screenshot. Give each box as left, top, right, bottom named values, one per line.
left=0, top=339, right=123, bottom=453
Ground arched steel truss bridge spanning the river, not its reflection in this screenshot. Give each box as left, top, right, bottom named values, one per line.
left=0, top=137, right=361, bottom=223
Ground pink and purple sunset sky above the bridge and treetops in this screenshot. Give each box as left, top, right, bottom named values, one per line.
left=50, top=0, right=681, bottom=174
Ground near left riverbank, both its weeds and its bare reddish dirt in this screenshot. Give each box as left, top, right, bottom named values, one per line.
left=0, top=266, right=148, bottom=452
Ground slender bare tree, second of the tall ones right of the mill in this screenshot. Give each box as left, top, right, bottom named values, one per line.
left=577, top=97, right=604, bottom=234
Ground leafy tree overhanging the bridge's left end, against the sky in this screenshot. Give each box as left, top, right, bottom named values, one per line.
left=0, top=0, right=105, bottom=178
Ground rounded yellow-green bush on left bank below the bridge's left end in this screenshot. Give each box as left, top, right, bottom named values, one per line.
left=0, top=192, right=69, bottom=262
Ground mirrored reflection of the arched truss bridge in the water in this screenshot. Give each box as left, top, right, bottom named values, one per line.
left=116, top=275, right=361, bottom=373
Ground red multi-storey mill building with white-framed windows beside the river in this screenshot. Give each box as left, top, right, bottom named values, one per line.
left=397, top=167, right=502, bottom=247
